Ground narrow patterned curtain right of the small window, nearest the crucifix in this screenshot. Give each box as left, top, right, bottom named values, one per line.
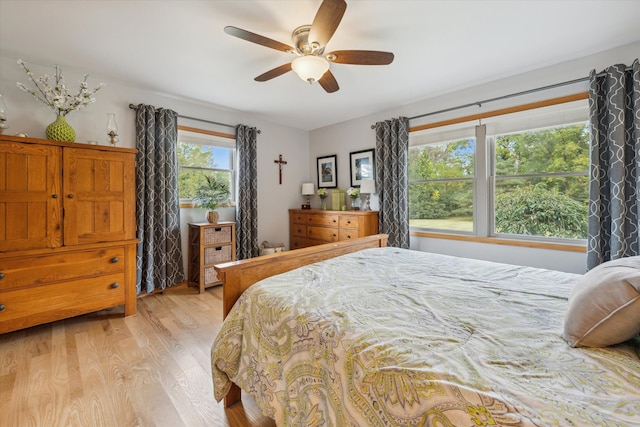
left=236, top=125, right=260, bottom=260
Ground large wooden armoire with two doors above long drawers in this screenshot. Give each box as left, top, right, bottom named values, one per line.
left=0, top=135, right=137, bottom=333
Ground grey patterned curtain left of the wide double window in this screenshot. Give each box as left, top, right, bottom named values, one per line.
left=375, top=117, right=409, bottom=249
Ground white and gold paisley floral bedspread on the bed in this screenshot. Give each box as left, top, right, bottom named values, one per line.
left=211, top=248, right=640, bottom=427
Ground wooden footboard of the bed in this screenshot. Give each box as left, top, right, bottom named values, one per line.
left=215, top=234, right=389, bottom=407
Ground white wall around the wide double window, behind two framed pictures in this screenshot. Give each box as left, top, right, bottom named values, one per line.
left=309, top=42, right=640, bottom=273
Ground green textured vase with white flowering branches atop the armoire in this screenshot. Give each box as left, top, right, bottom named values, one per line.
left=17, top=59, right=104, bottom=142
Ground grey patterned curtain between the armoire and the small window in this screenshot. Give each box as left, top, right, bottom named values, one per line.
left=136, top=104, right=184, bottom=294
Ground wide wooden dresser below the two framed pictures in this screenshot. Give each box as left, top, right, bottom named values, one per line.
left=289, top=209, right=378, bottom=249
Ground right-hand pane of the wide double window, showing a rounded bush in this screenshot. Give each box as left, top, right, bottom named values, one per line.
left=493, top=122, right=589, bottom=239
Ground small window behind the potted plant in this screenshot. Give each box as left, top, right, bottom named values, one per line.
left=178, top=130, right=236, bottom=200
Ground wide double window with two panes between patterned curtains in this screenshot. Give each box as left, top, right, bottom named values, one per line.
left=409, top=100, right=589, bottom=239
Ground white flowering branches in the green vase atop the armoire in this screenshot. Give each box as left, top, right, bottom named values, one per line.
left=17, top=59, right=104, bottom=116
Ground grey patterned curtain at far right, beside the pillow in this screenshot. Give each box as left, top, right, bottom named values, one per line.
left=587, top=59, right=640, bottom=269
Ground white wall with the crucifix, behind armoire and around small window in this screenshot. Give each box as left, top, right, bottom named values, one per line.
left=0, top=53, right=309, bottom=275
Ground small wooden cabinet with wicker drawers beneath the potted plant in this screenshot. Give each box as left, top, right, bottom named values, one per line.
left=189, top=222, right=236, bottom=293
